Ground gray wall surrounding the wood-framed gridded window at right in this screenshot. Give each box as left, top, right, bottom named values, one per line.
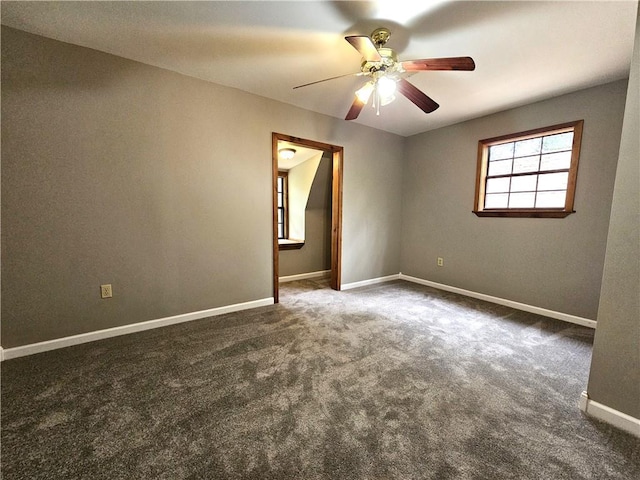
left=400, top=81, right=626, bottom=319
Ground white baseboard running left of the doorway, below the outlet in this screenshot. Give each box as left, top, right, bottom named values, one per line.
left=0, top=297, right=274, bottom=360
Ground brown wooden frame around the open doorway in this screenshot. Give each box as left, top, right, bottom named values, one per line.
left=271, top=132, right=344, bottom=303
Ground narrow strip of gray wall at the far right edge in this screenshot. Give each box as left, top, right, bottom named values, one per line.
left=587, top=10, right=640, bottom=418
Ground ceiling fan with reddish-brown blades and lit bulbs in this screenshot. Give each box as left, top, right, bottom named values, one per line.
left=293, top=28, right=476, bottom=120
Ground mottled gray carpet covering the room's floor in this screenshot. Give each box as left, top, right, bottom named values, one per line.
left=2, top=281, right=640, bottom=480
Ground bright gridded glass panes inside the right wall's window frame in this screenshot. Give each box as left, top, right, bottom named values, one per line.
left=484, top=132, right=573, bottom=209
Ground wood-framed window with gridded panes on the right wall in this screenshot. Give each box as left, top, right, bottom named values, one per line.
left=473, top=120, right=583, bottom=218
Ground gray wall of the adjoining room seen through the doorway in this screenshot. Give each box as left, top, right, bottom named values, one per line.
left=279, top=154, right=333, bottom=277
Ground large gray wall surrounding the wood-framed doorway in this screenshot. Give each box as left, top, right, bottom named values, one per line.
left=1, top=27, right=404, bottom=348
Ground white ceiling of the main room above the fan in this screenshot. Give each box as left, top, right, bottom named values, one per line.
left=1, top=0, right=637, bottom=136
